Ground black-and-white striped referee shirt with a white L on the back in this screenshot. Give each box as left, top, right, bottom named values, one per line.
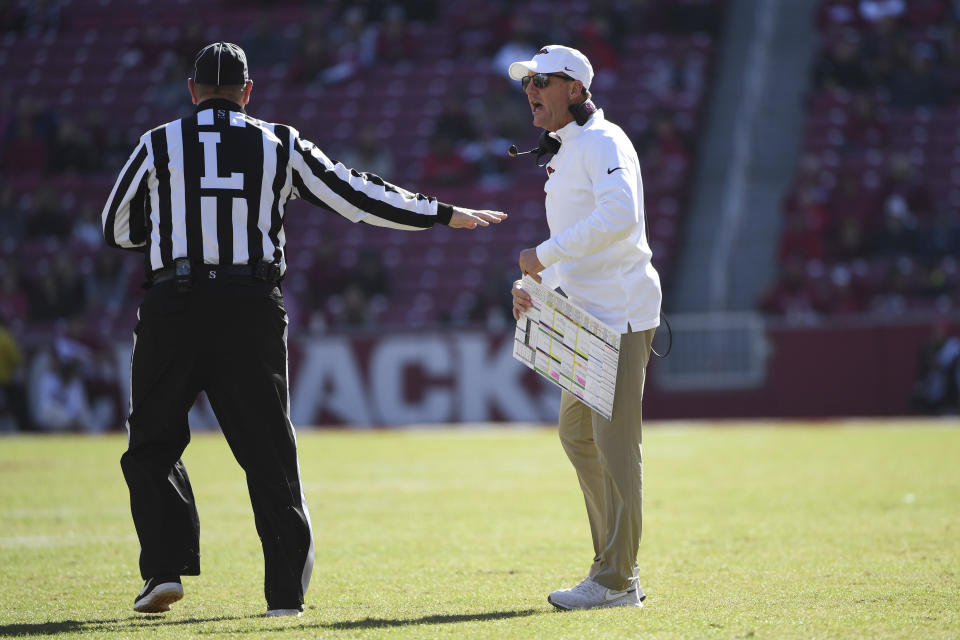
left=102, top=99, right=453, bottom=275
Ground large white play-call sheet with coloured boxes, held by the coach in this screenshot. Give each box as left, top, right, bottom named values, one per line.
left=513, top=276, right=620, bottom=420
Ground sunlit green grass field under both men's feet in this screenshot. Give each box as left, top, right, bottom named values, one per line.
left=0, top=422, right=960, bottom=640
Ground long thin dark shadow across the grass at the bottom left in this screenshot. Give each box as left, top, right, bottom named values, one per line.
left=0, top=609, right=542, bottom=638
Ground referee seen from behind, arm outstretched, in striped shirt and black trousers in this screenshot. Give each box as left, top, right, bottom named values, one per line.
left=103, top=42, right=506, bottom=616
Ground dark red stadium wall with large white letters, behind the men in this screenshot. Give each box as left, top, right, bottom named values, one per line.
left=9, top=316, right=960, bottom=428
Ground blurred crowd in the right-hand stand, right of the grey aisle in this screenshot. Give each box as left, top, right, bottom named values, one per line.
left=760, top=0, right=960, bottom=318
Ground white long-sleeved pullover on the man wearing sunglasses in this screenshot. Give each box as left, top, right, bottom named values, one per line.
left=537, top=110, right=662, bottom=333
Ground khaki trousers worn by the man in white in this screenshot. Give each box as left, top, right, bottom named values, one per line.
left=559, top=329, right=656, bottom=590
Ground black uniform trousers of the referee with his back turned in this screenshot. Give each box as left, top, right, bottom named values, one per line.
left=121, top=277, right=313, bottom=609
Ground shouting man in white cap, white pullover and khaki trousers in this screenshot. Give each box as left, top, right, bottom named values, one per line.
left=509, top=45, right=661, bottom=609
